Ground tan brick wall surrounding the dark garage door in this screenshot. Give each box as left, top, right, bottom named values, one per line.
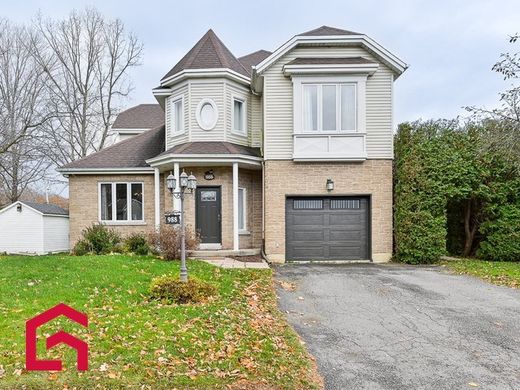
left=264, top=160, right=392, bottom=262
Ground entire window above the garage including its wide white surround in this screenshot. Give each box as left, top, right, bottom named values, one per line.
left=293, top=75, right=367, bottom=134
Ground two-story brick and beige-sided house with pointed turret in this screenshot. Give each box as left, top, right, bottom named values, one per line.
left=61, top=26, right=406, bottom=262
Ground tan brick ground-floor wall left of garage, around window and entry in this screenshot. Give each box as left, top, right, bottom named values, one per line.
left=69, top=166, right=262, bottom=249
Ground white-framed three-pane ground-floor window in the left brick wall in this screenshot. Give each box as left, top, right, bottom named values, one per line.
left=99, top=182, right=144, bottom=223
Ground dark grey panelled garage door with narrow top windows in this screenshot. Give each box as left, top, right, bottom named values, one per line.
left=285, top=197, right=370, bottom=261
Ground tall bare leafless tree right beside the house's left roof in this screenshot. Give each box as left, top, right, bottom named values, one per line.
left=33, top=9, right=142, bottom=165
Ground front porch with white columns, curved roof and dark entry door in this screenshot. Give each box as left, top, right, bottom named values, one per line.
left=150, top=145, right=263, bottom=257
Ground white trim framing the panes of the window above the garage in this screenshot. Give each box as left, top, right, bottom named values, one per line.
left=292, top=75, right=367, bottom=135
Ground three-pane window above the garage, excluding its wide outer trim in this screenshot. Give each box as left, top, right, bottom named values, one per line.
left=302, top=83, right=357, bottom=132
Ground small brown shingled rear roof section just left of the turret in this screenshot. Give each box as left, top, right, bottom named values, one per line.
left=112, top=104, right=164, bottom=129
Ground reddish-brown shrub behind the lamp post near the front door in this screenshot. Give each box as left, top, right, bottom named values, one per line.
left=149, top=225, right=199, bottom=260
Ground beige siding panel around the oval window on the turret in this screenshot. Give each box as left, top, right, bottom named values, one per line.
left=189, top=79, right=226, bottom=142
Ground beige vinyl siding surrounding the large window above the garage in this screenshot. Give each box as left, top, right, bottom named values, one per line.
left=263, top=46, right=393, bottom=159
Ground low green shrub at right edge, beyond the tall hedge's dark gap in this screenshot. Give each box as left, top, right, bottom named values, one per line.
left=477, top=204, right=520, bottom=261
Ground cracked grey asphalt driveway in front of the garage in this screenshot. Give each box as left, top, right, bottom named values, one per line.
left=275, top=264, right=520, bottom=390
